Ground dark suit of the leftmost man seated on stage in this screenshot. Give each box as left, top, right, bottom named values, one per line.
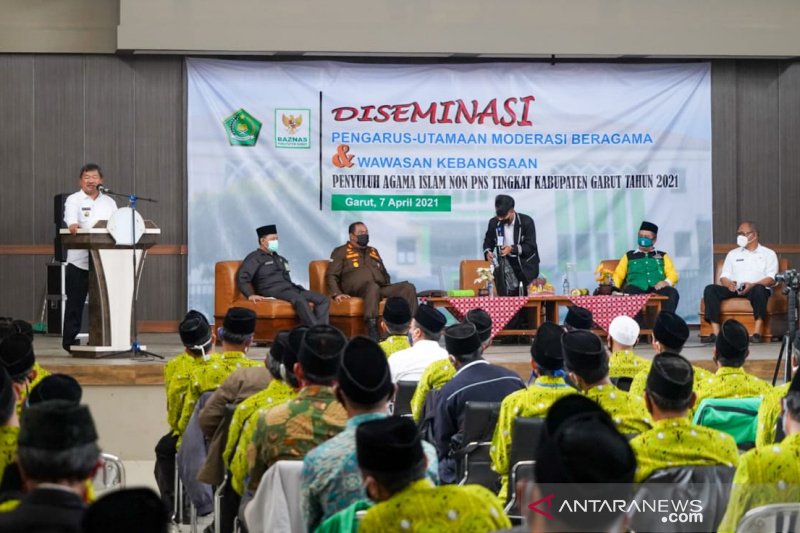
left=237, top=248, right=330, bottom=326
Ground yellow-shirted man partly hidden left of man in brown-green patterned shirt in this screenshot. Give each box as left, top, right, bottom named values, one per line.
left=228, top=325, right=308, bottom=496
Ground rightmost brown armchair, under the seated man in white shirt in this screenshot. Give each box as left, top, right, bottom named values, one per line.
left=700, top=258, right=789, bottom=341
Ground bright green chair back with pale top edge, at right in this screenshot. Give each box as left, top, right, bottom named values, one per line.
left=692, top=396, right=762, bottom=449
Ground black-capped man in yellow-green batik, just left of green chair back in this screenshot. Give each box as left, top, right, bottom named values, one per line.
left=631, top=352, right=739, bottom=482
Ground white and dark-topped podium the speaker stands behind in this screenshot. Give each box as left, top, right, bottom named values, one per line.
left=59, top=213, right=161, bottom=358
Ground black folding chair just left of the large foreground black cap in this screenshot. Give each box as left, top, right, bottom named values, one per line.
left=505, top=416, right=544, bottom=520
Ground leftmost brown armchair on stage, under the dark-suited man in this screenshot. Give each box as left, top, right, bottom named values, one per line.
left=214, top=261, right=300, bottom=342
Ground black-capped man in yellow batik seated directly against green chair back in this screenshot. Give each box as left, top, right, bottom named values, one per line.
left=695, top=320, right=772, bottom=406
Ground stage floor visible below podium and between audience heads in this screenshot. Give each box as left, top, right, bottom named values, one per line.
left=34, top=330, right=780, bottom=385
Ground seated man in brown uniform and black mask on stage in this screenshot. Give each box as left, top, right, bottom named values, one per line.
left=325, top=222, right=417, bottom=340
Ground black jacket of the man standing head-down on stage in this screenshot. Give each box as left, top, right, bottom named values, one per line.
left=483, top=213, right=539, bottom=296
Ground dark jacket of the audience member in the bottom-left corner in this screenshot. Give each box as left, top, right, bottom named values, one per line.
left=0, top=488, right=86, bottom=533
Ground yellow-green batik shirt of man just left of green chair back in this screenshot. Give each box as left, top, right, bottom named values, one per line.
left=630, top=417, right=739, bottom=483
